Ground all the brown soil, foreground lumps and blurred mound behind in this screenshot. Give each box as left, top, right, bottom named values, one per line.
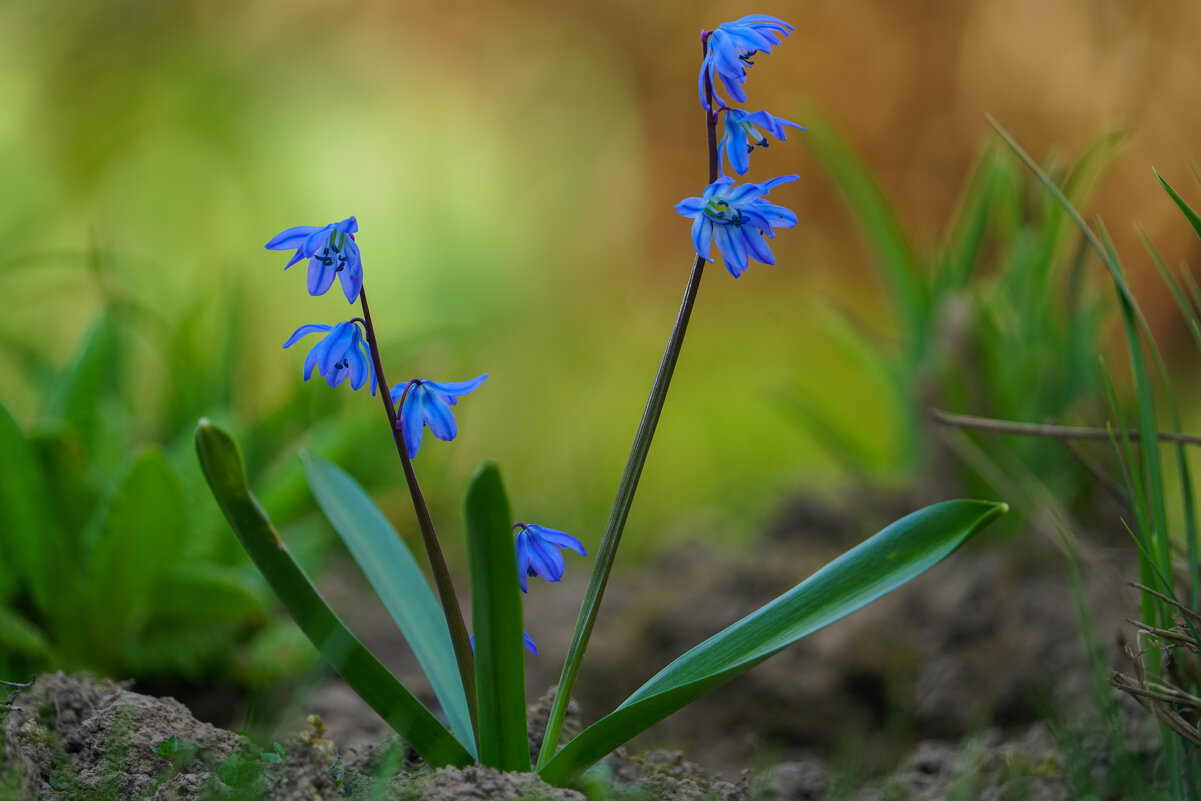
left=0, top=489, right=1157, bottom=801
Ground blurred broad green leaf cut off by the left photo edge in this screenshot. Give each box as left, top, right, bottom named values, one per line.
left=0, top=404, right=61, bottom=609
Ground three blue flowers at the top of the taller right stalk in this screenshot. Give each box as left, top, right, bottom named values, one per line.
left=675, top=14, right=805, bottom=277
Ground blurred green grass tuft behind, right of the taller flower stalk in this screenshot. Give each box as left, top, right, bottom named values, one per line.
left=791, top=114, right=1125, bottom=502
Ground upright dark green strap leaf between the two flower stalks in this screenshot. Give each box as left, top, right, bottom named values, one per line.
left=466, top=461, right=530, bottom=771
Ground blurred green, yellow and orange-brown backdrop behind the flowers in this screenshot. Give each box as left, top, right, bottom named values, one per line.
left=0, top=0, right=1201, bottom=686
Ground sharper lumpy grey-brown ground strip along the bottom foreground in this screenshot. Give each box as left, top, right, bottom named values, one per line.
left=0, top=674, right=1157, bottom=801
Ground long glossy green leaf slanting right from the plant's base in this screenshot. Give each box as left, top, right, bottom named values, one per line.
left=539, top=501, right=1008, bottom=784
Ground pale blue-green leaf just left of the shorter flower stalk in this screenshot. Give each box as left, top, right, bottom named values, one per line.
left=300, top=452, right=476, bottom=752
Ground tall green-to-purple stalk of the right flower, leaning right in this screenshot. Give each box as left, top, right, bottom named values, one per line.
left=538, top=31, right=719, bottom=770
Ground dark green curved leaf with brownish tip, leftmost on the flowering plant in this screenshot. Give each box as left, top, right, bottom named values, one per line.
left=196, top=419, right=474, bottom=767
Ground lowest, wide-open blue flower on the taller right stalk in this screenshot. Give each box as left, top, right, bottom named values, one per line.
left=676, top=175, right=797, bottom=277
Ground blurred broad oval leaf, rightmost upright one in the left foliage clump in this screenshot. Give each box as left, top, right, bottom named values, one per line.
left=83, top=450, right=187, bottom=668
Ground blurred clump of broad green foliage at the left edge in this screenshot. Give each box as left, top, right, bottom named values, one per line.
left=0, top=305, right=324, bottom=683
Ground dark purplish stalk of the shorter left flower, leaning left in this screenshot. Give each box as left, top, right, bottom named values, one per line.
left=359, top=288, right=479, bottom=752
